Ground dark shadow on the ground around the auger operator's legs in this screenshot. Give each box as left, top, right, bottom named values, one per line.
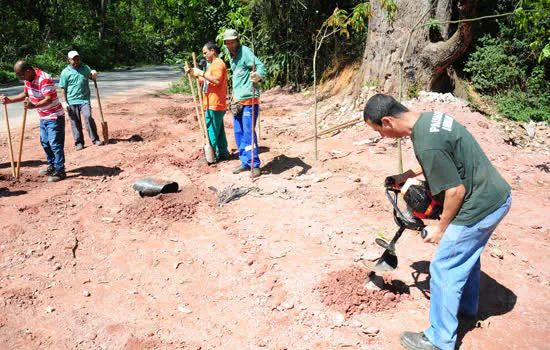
left=410, top=261, right=517, bottom=348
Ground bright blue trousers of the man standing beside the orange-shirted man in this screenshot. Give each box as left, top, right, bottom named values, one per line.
left=233, top=104, right=260, bottom=168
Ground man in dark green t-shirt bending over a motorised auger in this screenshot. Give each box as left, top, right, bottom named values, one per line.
left=364, top=94, right=512, bottom=350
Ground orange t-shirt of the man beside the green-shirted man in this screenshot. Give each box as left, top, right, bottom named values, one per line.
left=203, top=57, right=227, bottom=111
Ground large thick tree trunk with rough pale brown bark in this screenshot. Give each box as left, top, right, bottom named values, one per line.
left=354, top=0, right=477, bottom=97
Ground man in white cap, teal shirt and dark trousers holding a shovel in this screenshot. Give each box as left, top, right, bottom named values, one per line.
left=59, top=51, right=103, bottom=151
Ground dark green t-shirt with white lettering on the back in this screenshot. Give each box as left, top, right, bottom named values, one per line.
left=411, top=112, right=511, bottom=225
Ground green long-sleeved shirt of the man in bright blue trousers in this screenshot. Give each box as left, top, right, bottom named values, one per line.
left=230, top=45, right=266, bottom=102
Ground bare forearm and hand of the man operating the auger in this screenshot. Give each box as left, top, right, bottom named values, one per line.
left=424, top=184, right=466, bottom=243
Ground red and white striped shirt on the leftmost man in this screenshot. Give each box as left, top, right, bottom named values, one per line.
left=25, top=68, right=65, bottom=120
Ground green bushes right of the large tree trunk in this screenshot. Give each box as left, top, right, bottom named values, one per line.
left=464, top=0, right=550, bottom=121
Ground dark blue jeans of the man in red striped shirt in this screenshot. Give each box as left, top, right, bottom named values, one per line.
left=40, top=115, right=65, bottom=169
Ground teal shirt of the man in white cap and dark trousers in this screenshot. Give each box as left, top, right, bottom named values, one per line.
left=59, top=64, right=92, bottom=105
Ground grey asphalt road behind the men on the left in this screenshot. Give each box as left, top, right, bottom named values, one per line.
left=0, top=66, right=182, bottom=131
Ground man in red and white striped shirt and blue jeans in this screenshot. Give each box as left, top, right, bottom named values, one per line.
left=0, top=61, right=66, bottom=182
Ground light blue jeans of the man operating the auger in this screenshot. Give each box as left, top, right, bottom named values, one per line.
left=424, top=194, right=512, bottom=350
